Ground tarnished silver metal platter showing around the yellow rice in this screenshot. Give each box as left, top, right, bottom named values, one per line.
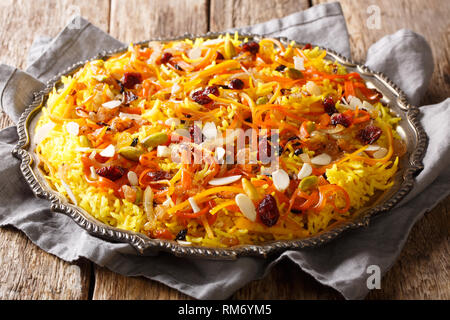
left=9, top=33, right=428, bottom=259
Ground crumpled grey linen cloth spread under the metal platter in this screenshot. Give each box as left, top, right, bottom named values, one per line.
left=0, top=3, right=450, bottom=299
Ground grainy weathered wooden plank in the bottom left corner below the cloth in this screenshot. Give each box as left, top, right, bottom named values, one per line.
left=0, top=227, right=91, bottom=300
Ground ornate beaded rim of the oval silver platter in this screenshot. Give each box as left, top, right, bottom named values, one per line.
left=12, top=32, right=428, bottom=260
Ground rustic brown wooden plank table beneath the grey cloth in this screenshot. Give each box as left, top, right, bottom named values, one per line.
left=0, top=0, right=450, bottom=299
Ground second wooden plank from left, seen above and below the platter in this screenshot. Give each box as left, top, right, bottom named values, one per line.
left=93, top=0, right=208, bottom=299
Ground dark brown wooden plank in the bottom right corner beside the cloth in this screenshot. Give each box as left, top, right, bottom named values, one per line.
left=367, top=197, right=450, bottom=300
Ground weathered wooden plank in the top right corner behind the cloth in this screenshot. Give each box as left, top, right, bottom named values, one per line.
left=313, top=0, right=450, bottom=104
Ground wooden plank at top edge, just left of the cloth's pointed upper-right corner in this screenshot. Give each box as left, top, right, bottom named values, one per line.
left=210, top=0, right=309, bottom=31
